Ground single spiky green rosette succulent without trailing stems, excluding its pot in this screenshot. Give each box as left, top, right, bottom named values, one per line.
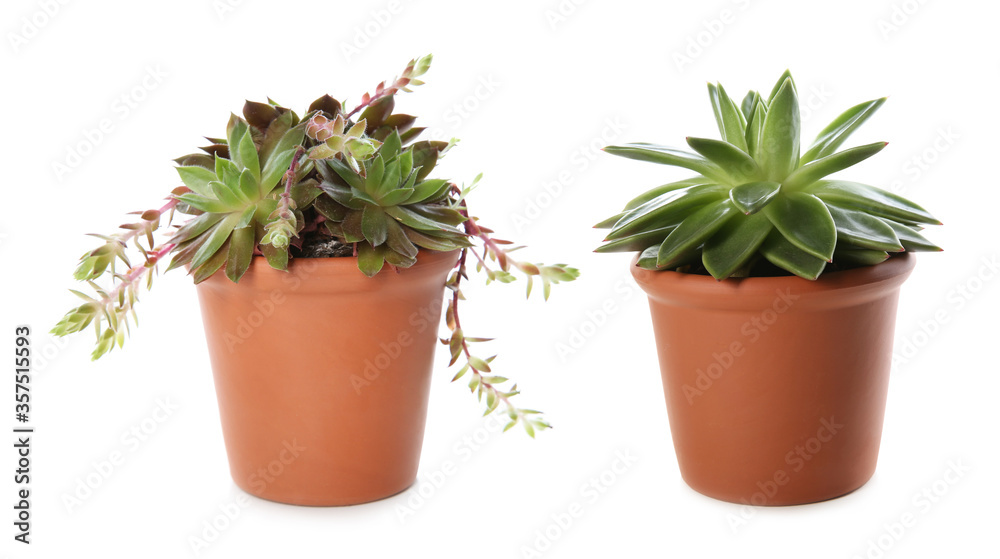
left=596, top=71, right=941, bottom=280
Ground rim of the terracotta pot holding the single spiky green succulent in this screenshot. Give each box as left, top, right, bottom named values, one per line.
left=630, top=252, right=916, bottom=309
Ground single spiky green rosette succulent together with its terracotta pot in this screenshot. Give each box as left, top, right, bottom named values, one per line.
left=597, top=72, right=941, bottom=505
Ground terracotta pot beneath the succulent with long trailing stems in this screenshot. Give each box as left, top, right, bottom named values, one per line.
left=198, top=251, right=458, bottom=506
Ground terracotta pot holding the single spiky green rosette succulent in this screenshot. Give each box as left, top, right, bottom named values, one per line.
left=632, top=254, right=915, bottom=505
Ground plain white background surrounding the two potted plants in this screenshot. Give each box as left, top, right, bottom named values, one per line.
left=0, top=0, right=1000, bottom=559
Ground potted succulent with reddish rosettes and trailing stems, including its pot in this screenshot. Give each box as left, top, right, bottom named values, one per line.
left=53, top=56, right=578, bottom=505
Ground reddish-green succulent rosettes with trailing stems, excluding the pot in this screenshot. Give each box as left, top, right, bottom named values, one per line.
left=52, top=55, right=579, bottom=436
